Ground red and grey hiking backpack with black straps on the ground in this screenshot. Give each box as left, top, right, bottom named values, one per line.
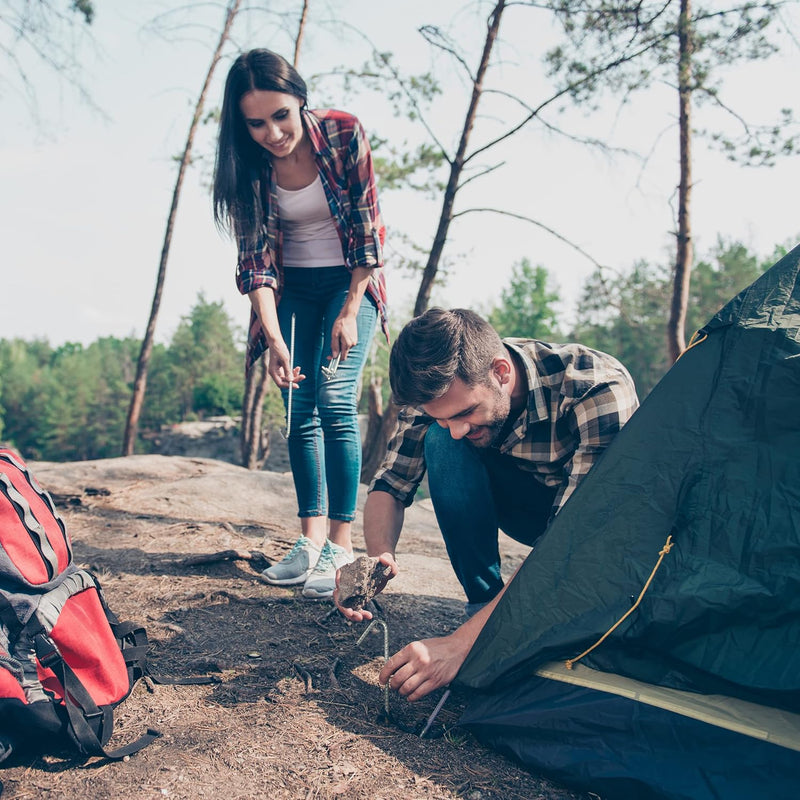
left=0, top=448, right=160, bottom=762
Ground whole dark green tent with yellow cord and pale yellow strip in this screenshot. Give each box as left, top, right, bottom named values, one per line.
left=456, top=247, right=800, bottom=800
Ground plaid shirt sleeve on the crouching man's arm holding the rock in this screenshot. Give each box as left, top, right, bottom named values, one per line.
left=369, top=408, right=433, bottom=508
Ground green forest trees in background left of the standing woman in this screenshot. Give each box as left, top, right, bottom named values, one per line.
left=0, top=295, right=250, bottom=461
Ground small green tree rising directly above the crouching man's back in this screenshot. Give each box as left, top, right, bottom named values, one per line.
left=489, top=258, right=560, bottom=341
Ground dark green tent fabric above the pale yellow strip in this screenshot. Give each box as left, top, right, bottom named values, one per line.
left=456, top=241, right=800, bottom=711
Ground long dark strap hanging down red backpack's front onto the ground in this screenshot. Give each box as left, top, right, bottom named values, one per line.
left=33, top=632, right=161, bottom=760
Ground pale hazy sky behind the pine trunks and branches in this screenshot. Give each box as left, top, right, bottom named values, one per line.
left=0, top=0, right=800, bottom=345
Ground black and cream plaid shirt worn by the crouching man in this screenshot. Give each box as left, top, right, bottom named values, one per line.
left=369, top=339, right=639, bottom=514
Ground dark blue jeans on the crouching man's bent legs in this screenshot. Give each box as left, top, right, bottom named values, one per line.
left=425, top=424, right=557, bottom=604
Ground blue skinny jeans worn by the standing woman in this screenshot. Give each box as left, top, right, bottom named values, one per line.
left=278, top=266, right=378, bottom=522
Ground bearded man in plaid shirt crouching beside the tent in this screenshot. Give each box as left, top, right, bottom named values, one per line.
left=340, top=308, right=638, bottom=700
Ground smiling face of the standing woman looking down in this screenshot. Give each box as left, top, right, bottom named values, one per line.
left=239, top=89, right=305, bottom=158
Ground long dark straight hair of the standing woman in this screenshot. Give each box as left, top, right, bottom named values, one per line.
left=214, top=49, right=308, bottom=242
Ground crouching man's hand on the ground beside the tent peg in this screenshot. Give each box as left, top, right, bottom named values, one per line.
left=378, top=631, right=472, bottom=701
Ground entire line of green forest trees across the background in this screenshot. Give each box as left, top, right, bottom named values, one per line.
left=0, top=240, right=786, bottom=461
